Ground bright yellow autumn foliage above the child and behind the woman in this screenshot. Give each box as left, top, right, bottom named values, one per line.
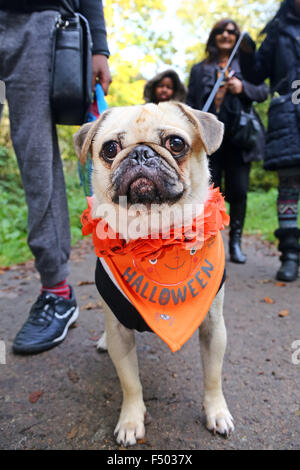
left=105, top=0, right=280, bottom=106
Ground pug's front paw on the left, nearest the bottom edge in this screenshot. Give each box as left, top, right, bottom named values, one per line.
left=114, top=404, right=146, bottom=446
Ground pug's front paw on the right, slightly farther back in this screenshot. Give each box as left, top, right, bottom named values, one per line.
left=204, top=399, right=234, bottom=437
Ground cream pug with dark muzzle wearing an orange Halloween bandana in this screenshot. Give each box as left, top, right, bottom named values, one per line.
left=74, top=102, right=234, bottom=446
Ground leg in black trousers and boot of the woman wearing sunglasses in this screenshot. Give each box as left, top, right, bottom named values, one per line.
left=225, top=149, right=250, bottom=264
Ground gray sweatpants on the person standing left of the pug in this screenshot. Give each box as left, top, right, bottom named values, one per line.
left=0, top=10, right=70, bottom=287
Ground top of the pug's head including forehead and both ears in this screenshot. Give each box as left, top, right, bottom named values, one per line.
left=74, top=101, right=224, bottom=164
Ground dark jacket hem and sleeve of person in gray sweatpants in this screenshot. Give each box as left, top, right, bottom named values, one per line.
left=0, top=0, right=109, bottom=57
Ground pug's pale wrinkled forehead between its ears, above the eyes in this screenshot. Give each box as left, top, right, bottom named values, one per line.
left=94, top=103, right=193, bottom=147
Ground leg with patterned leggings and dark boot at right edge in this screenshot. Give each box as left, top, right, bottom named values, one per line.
left=275, top=168, right=300, bottom=282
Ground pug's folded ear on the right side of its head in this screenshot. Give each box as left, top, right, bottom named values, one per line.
left=178, top=103, right=224, bottom=155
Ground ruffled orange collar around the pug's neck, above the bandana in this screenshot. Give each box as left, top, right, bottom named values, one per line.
left=81, top=186, right=229, bottom=259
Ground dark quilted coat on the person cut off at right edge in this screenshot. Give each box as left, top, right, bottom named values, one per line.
left=240, top=14, right=300, bottom=170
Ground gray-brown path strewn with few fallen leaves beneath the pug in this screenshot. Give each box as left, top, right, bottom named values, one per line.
left=0, top=233, right=300, bottom=450
